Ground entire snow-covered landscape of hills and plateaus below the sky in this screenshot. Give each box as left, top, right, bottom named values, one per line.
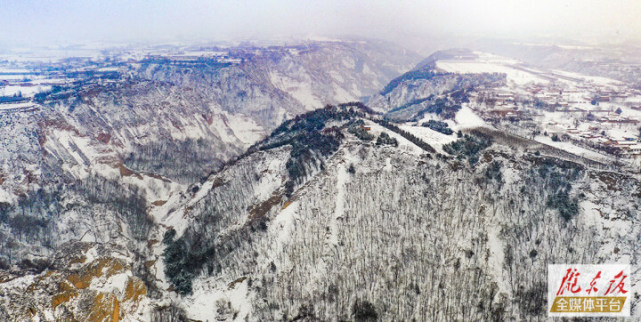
left=0, top=41, right=641, bottom=321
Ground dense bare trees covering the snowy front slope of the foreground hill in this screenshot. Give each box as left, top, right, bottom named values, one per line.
left=166, top=132, right=639, bottom=320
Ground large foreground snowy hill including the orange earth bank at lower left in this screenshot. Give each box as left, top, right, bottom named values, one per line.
left=0, top=105, right=641, bottom=321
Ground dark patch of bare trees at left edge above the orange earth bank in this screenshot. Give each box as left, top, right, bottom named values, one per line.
left=0, top=176, right=153, bottom=268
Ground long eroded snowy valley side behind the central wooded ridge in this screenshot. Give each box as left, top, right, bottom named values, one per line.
left=0, top=42, right=415, bottom=266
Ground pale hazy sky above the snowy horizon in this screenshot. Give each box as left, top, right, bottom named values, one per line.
left=0, top=0, right=641, bottom=47
